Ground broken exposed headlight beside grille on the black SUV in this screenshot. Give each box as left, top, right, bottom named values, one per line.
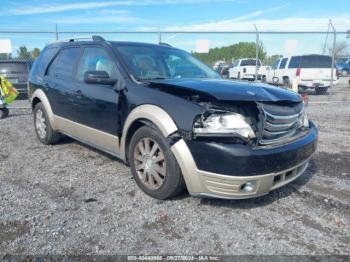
left=193, top=112, right=255, bottom=139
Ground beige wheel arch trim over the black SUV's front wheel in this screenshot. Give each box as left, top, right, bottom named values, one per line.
left=120, top=104, right=178, bottom=162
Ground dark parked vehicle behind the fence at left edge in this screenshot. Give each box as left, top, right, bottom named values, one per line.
left=0, top=59, right=33, bottom=98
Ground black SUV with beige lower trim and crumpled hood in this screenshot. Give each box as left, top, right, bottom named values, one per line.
left=29, top=36, right=317, bottom=199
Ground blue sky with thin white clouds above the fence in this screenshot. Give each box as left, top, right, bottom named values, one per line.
left=0, top=0, right=350, bottom=59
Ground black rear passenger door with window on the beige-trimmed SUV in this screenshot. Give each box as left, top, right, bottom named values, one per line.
left=44, top=47, right=81, bottom=121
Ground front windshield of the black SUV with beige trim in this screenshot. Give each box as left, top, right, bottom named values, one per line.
left=117, top=45, right=220, bottom=81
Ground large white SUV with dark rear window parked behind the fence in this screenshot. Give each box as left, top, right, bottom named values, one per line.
left=266, top=55, right=339, bottom=94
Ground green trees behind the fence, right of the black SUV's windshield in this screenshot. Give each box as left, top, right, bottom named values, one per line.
left=193, top=42, right=266, bottom=64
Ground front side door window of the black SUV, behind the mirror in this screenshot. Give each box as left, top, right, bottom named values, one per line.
left=77, top=47, right=118, bottom=81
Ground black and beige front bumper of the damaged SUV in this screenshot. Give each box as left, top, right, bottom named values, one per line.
left=171, top=123, right=317, bottom=199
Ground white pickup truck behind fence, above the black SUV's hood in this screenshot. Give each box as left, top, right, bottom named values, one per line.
left=228, top=58, right=265, bottom=80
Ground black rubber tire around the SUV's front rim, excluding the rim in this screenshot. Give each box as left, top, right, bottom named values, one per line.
left=128, top=126, right=184, bottom=199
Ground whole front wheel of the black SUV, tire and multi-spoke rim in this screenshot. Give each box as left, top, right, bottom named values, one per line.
left=128, top=126, right=185, bottom=199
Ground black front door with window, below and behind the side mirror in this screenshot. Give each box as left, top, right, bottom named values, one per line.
left=74, top=45, right=122, bottom=135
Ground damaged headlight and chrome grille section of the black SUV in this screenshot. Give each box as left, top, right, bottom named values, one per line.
left=185, top=94, right=309, bottom=146
